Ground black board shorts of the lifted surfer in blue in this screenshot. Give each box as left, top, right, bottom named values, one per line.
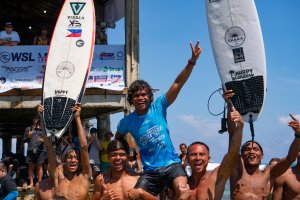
left=134, top=163, right=186, bottom=196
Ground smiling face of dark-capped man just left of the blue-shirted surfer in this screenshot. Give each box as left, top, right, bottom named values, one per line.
left=108, top=149, right=127, bottom=172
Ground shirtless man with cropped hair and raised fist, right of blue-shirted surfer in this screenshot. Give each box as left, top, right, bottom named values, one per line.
left=187, top=106, right=244, bottom=200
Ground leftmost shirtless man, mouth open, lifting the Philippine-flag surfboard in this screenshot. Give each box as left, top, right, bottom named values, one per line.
left=41, top=103, right=91, bottom=200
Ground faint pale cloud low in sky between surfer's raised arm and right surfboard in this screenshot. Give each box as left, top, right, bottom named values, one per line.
left=178, top=115, right=221, bottom=136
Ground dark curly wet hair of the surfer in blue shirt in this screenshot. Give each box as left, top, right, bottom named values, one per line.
left=127, top=80, right=153, bottom=105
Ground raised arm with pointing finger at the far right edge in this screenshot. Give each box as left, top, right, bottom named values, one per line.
left=270, top=114, right=300, bottom=180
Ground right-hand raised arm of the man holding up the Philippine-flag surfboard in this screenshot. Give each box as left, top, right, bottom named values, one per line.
left=72, top=103, right=92, bottom=177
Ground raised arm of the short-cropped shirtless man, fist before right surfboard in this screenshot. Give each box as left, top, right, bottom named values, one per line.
left=216, top=107, right=244, bottom=188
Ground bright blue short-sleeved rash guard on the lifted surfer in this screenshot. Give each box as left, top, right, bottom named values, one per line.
left=117, top=95, right=180, bottom=170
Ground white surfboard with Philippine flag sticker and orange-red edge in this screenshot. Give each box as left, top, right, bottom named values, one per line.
left=43, top=0, right=95, bottom=137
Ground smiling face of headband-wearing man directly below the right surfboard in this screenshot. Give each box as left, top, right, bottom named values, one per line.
left=242, top=142, right=263, bottom=166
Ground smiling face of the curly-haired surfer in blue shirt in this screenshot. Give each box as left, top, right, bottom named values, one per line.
left=132, top=89, right=150, bottom=115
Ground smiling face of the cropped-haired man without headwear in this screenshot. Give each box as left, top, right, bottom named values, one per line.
left=188, top=144, right=210, bottom=174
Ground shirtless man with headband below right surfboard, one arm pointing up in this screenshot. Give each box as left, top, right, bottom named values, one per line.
left=224, top=90, right=300, bottom=200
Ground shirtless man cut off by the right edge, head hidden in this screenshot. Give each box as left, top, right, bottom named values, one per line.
left=273, top=138, right=300, bottom=200
